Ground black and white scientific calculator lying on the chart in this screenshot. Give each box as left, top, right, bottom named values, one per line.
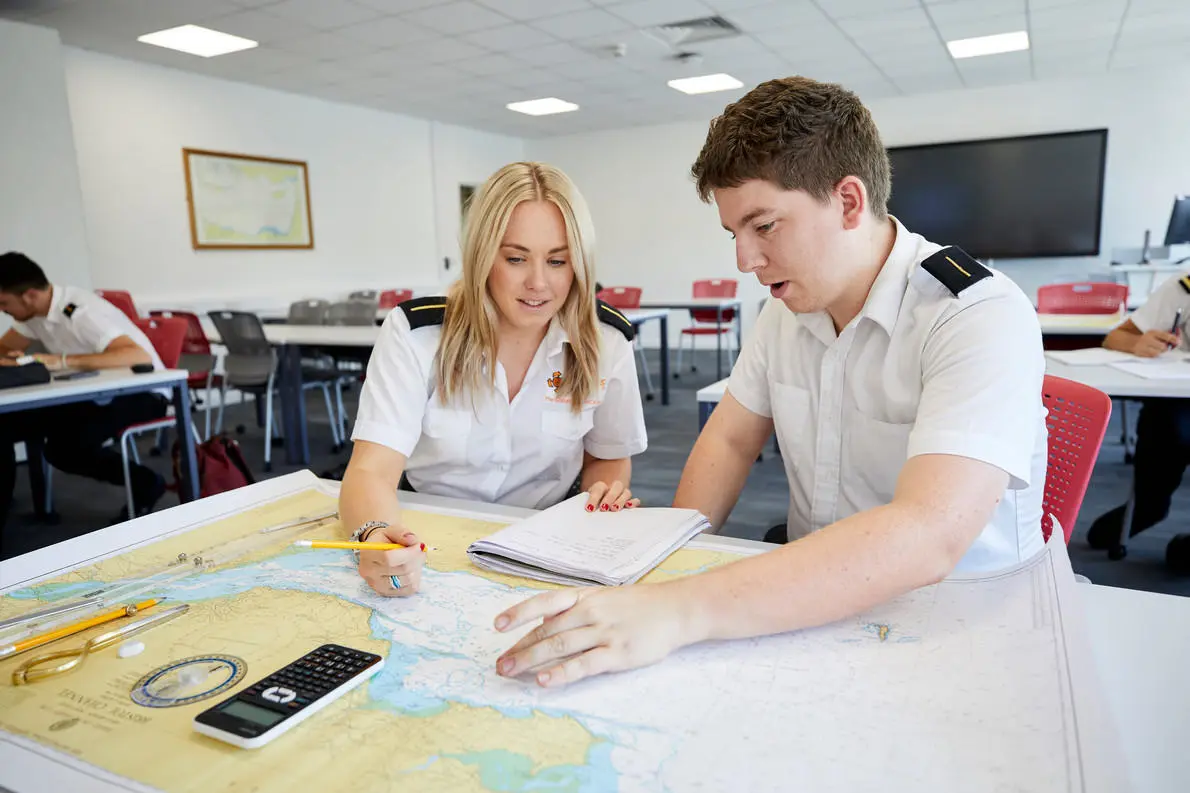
left=194, top=644, right=384, bottom=749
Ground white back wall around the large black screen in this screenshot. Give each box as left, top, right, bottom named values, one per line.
left=528, top=70, right=1190, bottom=343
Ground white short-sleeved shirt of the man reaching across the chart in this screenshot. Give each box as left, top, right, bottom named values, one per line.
left=728, top=221, right=1046, bottom=572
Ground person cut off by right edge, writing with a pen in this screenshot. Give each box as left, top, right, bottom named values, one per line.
left=1086, top=276, right=1190, bottom=550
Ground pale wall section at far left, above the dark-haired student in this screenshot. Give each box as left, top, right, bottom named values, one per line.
left=0, top=20, right=90, bottom=292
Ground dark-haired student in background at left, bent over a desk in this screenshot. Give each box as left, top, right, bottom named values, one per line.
left=0, top=252, right=169, bottom=523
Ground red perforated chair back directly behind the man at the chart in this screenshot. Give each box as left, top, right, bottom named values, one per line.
left=1041, top=375, right=1111, bottom=543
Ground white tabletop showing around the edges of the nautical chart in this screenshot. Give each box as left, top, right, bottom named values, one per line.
left=0, top=472, right=1190, bottom=793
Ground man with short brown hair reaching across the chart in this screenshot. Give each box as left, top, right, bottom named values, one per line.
left=487, top=77, right=1046, bottom=686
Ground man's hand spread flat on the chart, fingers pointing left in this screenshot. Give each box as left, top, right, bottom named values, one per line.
left=496, top=583, right=701, bottom=687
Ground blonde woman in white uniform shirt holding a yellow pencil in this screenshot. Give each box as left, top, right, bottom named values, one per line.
left=339, top=162, right=646, bottom=595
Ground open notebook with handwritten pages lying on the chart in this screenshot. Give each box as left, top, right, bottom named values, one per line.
left=466, top=493, right=710, bottom=586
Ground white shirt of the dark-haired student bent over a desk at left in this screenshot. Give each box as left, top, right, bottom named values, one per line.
left=12, top=285, right=170, bottom=371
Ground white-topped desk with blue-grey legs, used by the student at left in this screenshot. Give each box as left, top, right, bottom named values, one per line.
left=0, top=369, right=199, bottom=502
